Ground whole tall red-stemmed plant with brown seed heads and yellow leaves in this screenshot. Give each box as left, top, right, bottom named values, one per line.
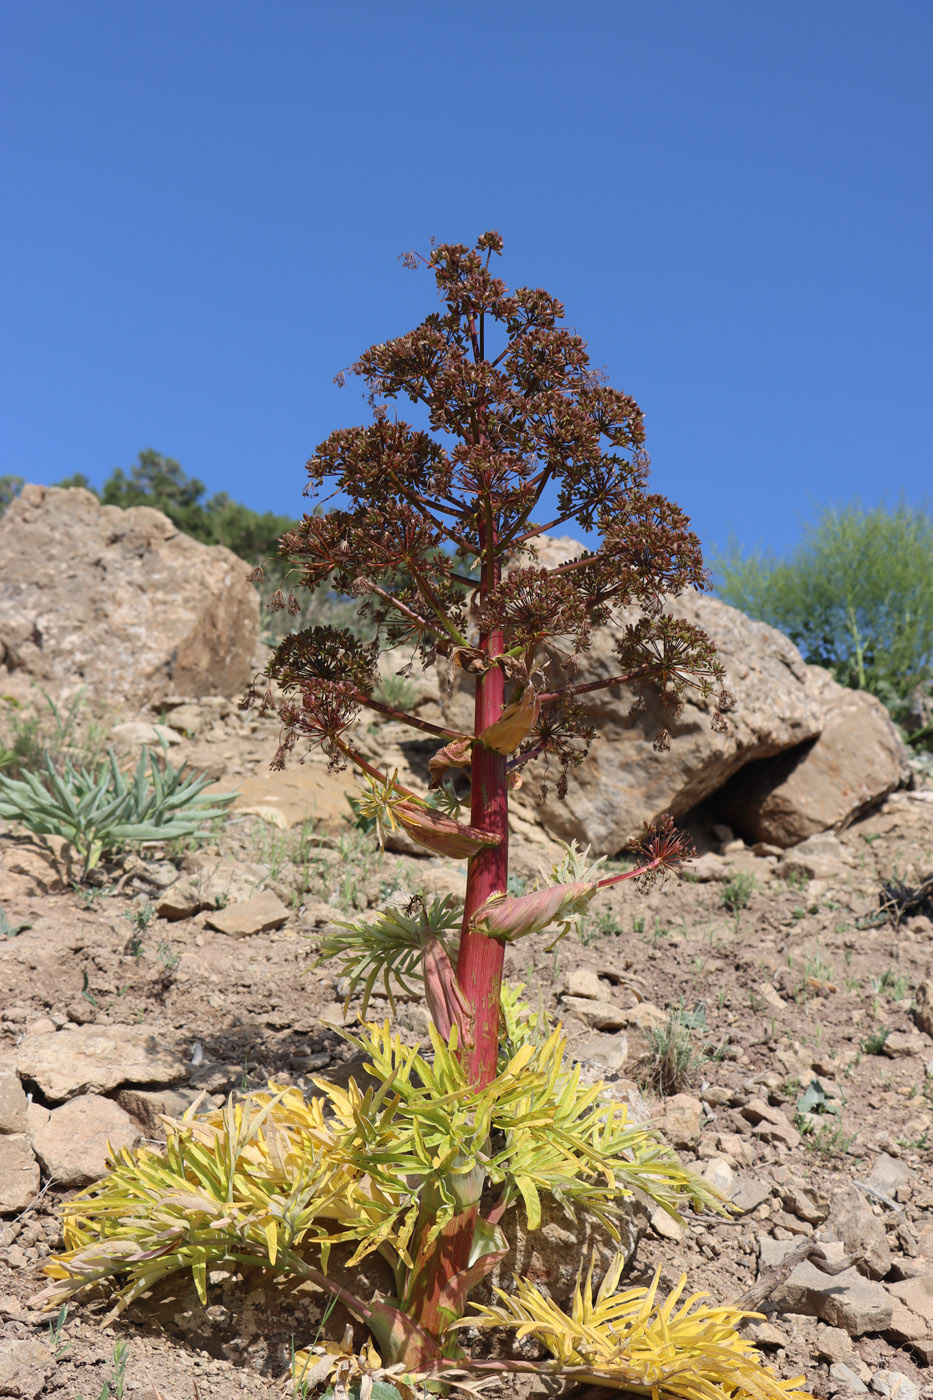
left=45, top=232, right=806, bottom=1400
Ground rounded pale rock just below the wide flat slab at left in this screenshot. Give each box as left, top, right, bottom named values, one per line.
left=32, top=1093, right=140, bottom=1186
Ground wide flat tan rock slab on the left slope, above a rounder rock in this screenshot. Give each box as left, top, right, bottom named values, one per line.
left=17, top=1026, right=188, bottom=1103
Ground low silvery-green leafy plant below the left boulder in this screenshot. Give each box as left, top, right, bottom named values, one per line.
left=0, top=749, right=235, bottom=878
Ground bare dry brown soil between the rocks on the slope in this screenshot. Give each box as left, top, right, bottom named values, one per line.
left=0, top=705, right=933, bottom=1400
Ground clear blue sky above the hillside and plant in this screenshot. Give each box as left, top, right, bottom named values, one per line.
left=0, top=0, right=933, bottom=552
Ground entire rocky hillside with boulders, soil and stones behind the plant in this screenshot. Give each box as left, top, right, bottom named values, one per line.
left=0, top=487, right=933, bottom=1400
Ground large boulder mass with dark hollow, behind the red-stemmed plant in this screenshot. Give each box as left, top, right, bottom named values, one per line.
left=440, top=538, right=906, bottom=853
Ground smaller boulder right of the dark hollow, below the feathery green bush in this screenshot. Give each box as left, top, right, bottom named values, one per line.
left=716, top=666, right=909, bottom=846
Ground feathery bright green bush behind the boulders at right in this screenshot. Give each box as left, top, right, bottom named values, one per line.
left=714, top=501, right=933, bottom=717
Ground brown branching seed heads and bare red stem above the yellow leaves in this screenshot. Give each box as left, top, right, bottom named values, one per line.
left=250, top=232, right=730, bottom=1084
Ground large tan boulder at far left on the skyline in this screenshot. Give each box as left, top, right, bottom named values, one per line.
left=0, top=486, right=259, bottom=706
